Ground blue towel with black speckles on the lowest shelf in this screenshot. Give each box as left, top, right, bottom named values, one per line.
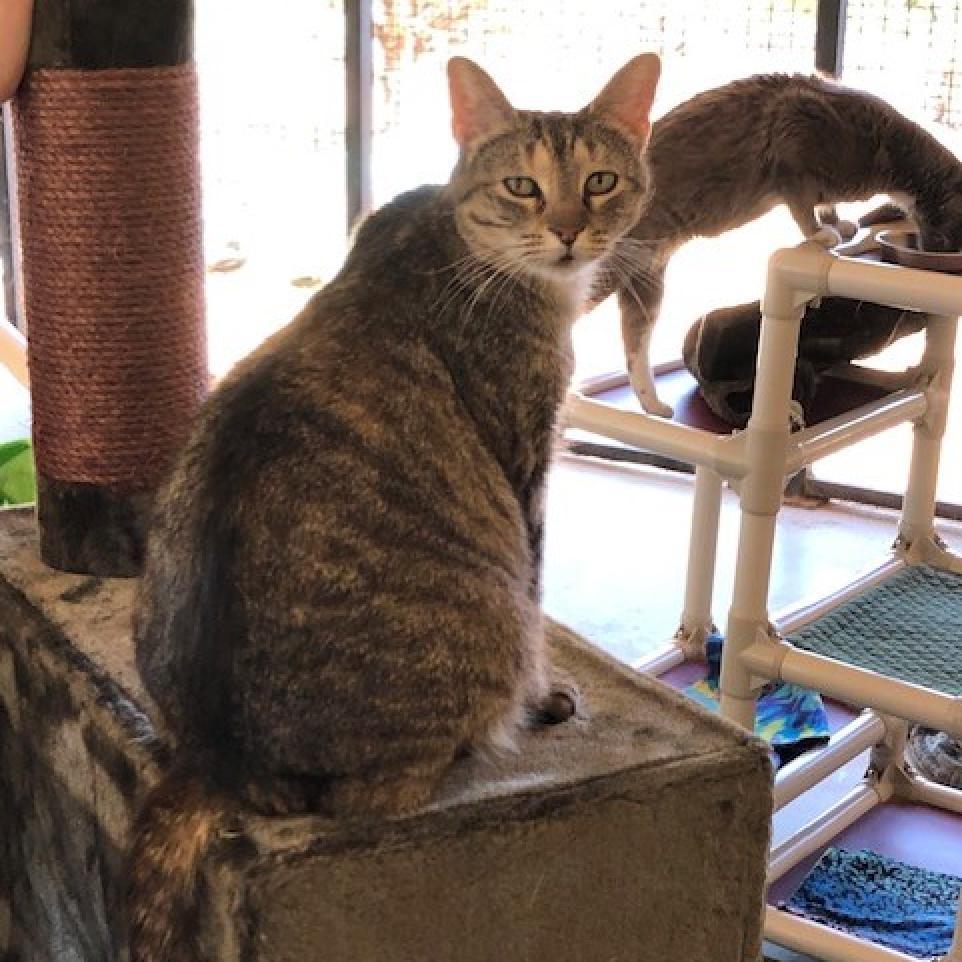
left=780, top=848, right=962, bottom=959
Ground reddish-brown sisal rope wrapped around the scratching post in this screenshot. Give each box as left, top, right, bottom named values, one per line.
left=15, top=65, right=208, bottom=491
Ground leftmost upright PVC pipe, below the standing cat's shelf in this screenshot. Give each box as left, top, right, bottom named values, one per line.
left=681, top=465, right=722, bottom=633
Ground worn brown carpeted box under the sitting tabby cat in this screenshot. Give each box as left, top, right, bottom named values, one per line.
left=0, top=511, right=771, bottom=962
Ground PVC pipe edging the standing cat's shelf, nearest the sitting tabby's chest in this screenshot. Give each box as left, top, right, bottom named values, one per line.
left=564, top=391, right=745, bottom=478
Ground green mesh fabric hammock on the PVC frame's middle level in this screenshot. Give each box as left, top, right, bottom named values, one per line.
left=788, top=565, right=962, bottom=695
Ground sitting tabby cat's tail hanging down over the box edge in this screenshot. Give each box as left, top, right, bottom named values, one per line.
left=126, top=773, right=228, bottom=962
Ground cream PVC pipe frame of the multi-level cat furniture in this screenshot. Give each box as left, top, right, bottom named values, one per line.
left=568, top=241, right=962, bottom=962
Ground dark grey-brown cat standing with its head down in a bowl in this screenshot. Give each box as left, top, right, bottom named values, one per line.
left=598, top=67, right=962, bottom=417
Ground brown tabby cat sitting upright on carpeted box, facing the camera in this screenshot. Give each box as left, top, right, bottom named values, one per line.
left=128, top=54, right=660, bottom=962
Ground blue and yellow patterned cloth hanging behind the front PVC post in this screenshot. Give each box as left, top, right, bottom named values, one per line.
left=685, top=633, right=831, bottom=765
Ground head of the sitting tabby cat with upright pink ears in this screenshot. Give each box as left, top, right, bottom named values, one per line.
left=449, top=54, right=659, bottom=283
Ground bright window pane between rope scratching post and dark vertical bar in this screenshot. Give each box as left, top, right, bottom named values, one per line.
left=195, top=0, right=347, bottom=375
